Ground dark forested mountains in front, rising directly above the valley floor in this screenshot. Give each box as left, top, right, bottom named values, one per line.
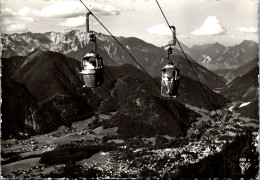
left=2, top=50, right=229, bottom=138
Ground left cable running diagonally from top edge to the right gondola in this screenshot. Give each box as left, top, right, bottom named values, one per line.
left=80, top=0, right=161, bottom=87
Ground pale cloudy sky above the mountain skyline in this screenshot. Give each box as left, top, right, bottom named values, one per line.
left=1, top=0, right=259, bottom=47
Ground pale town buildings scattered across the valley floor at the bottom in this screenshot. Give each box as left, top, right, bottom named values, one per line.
left=2, top=105, right=259, bottom=178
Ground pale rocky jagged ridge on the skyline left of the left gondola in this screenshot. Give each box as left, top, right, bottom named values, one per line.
left=1, top=30, right=89, bottom=56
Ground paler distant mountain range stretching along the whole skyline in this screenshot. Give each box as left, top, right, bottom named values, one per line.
left=1, top=30, right=258, bottom=75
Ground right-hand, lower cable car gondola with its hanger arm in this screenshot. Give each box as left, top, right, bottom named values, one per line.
left=161, top=26, right=180, bottom=98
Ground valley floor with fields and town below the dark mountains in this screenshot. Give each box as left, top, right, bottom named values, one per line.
left=1, top=103, right=259, bottom=178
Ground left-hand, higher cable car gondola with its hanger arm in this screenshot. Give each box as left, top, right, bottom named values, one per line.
left=80, top=12, right=104, bottom=88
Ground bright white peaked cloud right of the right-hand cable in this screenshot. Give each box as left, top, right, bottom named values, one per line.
left=191, top=16, right=227, bottom=36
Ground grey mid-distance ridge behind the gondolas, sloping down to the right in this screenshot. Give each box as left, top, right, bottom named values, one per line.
left=67, top=38, right=226, bottom=88
